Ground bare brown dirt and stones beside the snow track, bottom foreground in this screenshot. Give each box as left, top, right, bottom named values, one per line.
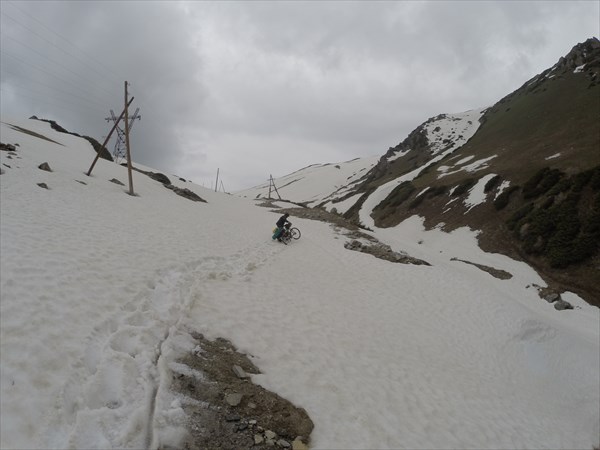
left=166, top=334, right=314, bottom=450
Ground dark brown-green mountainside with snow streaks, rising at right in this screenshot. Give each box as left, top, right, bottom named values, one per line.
left=248, top=38, right=600, bottom=306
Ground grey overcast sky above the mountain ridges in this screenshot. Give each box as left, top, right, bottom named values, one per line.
left=0, top=0, right=600, bottom=191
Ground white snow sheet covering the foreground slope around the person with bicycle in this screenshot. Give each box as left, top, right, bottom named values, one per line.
left=0, top=118, right=600, bottom=449
